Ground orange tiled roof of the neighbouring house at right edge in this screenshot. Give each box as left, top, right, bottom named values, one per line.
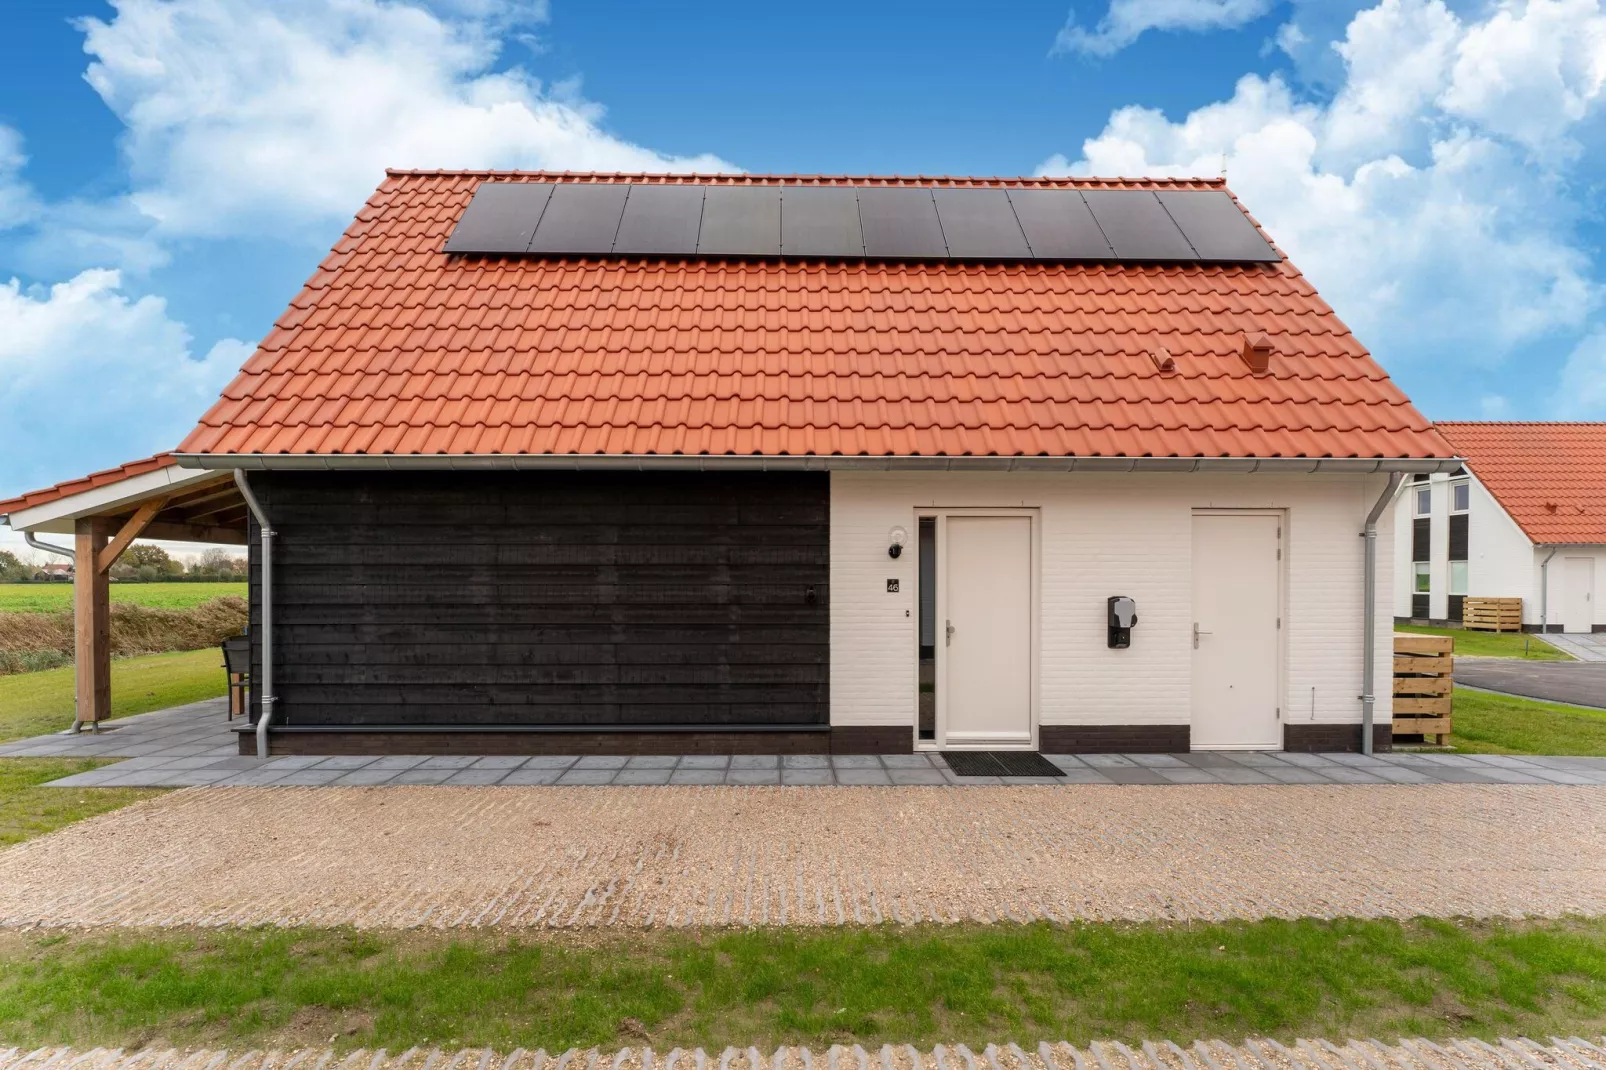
left=1437, top=421, right=1606, bottom=543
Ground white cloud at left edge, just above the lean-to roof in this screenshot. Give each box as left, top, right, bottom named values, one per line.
left=0, top=270, right=251, bottom=496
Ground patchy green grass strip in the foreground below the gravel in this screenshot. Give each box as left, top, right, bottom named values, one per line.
left=0, top=919, right=1606, bottom=1051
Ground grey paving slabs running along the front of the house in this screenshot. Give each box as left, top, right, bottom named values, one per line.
left=9, top=699, right=1606, bottom=787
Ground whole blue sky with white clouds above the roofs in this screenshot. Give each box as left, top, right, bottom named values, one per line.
left=0, top=0, right=1606, bottom=517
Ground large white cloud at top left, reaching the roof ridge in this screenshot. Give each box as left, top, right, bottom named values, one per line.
left=70, top=0, right=732, bottom=236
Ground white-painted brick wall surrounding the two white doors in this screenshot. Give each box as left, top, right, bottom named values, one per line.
left=830, top=472, right=1394, bottom=725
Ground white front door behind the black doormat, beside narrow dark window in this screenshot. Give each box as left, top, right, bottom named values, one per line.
left=936, top=516, right=1033, bottom=749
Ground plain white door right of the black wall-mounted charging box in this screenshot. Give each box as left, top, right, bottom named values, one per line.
left=1192, top=513, right=1283, bottom=750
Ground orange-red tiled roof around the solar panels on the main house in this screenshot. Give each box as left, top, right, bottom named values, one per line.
left=178, top=172, right=1452, bottom=458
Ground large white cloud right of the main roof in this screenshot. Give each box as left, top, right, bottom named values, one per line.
left=1042, top=0, right=1606, bottom=377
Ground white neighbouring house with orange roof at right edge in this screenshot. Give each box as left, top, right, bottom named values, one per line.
left=1394, top=421, right=1606, bottom=631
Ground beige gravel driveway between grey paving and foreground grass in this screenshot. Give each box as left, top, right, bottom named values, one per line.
left=0, top=784, right=1606, bottom=927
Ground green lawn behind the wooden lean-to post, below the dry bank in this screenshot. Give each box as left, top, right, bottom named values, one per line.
left=0, top=647, right=228, bottom=742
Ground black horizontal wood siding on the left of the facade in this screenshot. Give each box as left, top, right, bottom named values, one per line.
left=251, top=472, right=830, bottom=728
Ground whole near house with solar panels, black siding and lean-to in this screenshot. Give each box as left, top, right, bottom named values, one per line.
left=0, top=172, right=1460, bottom=753
